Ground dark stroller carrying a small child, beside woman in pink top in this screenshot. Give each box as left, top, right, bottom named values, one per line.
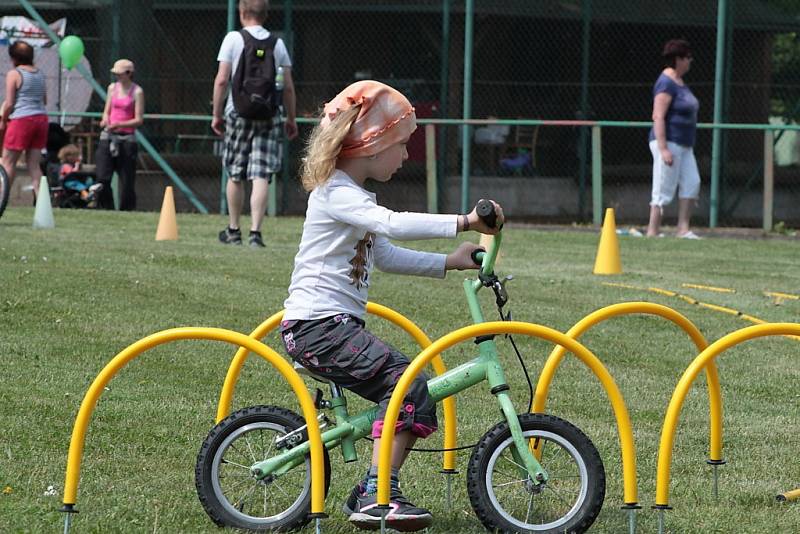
left=41, top=122, right=104, bottom=209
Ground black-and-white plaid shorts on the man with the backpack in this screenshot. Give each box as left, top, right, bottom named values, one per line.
left=222, top=110, right=283, bottom=182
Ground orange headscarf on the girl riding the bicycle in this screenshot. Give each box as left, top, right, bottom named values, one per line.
left=321, top=80, right=417, bottom=158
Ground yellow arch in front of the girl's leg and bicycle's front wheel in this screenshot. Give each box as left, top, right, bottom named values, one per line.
left=378, top=321, right=637, bottom=505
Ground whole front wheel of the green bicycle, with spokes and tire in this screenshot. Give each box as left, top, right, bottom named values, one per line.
left=467, top=413, right=606, bottom=533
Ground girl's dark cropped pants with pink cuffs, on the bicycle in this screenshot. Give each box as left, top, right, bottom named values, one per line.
left=281, top=314, right=438, bottom=438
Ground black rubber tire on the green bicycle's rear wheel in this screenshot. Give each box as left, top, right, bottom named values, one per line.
left=195, top=406, right=331, bottom=532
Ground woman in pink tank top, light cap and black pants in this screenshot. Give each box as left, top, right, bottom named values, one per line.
left=96, top=59, right=144, bottom=211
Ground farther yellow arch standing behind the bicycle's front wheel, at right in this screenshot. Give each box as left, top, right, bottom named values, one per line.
left=531, top=302, right=722, bottom=461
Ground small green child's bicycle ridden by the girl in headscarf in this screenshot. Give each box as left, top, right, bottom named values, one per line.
left=195, top=201, right=605, bottom=533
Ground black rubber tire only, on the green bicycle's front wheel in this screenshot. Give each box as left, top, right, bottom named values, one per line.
left=467, top=413, right=605, bottom=534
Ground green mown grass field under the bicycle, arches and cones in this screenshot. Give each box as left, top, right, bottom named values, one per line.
left=0, top=208, right=800, bottom=533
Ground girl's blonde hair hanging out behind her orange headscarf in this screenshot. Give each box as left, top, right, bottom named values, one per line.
left=300, top=105, right=361, bottom=192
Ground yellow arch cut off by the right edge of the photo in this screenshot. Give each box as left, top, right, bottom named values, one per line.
left=656, top=323, right=800, bottom=508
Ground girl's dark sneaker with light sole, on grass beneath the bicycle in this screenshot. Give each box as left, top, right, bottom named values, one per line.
left=348, top=489, right=433, bottom=532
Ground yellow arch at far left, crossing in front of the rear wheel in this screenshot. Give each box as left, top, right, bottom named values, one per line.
left=63, top=327, right=325, bottom=514
